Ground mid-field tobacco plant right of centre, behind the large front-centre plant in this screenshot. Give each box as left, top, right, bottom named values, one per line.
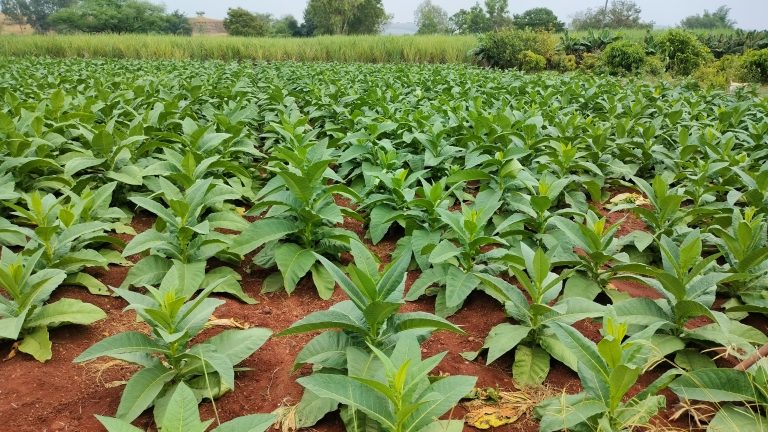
left=406, top=190, right=513, bottom=317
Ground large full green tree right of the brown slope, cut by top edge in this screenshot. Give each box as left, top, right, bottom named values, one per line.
left=304, top=0, right=389, bottom=35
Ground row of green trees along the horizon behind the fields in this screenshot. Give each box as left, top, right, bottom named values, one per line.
left=0, top=0, right=756, bottom=37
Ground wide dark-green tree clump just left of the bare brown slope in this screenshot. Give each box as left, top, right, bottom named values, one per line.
left=48, top=0, right=192, bottom=36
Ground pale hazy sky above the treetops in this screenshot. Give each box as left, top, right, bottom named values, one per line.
left=153, top=0, right=768, bottom=30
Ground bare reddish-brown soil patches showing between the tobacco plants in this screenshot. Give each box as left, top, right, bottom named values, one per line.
left=0, top=203, right=756, bottom=432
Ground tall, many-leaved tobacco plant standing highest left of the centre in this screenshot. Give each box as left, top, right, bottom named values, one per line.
left=228, top=137, right=361, bottom=300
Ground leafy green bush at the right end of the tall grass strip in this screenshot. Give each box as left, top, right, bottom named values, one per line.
left=473, top=29, right=557, bottom=69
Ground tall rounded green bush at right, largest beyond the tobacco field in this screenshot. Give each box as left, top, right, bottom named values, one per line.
left=658, top=30, right=714, bottom=75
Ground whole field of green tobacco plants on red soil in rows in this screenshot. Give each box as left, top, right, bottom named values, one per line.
left=0, top=58, right=768, bottom=432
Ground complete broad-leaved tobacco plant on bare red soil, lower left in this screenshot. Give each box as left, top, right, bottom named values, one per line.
left=74, top=262, right=271, bottom=422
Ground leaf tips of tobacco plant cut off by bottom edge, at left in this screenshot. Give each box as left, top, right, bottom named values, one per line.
left=96, top=383, right=276, bottom=432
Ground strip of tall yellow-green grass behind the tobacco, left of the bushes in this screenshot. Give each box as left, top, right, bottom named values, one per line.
left=0, top=35, right=477, bottom=63
